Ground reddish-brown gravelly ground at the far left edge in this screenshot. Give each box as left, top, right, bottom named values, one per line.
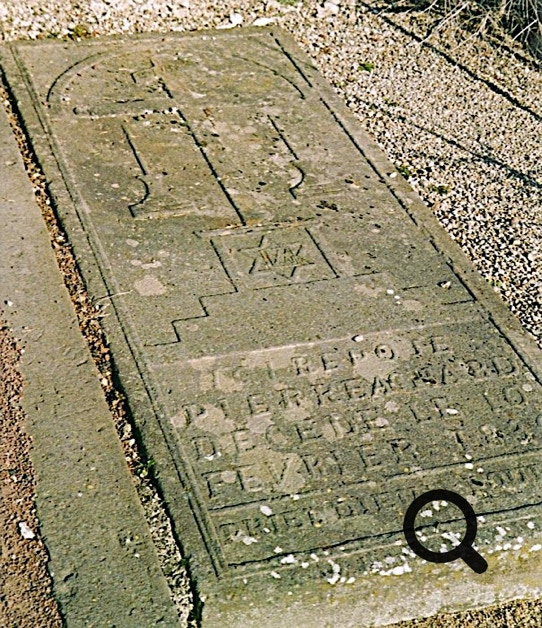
left=0, top=323, right=62, bottom=628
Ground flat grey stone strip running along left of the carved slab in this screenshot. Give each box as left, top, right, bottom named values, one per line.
left=0, top=84, right=179, bottom=627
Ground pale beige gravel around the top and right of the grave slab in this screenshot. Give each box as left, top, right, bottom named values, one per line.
left=0, top=0, right=542, bottom=626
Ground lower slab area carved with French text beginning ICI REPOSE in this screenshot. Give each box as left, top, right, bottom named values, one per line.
left=154, top=322, right=542, bottom=563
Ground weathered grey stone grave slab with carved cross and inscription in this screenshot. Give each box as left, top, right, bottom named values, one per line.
left=2, top=29, right=542, bottom=627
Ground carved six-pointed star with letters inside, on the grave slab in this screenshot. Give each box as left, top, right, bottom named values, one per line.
left=238, top=235, right=314, bottom=279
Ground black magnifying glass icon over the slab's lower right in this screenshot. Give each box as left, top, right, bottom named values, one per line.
left=403, top=489, right=488, bottom=573
